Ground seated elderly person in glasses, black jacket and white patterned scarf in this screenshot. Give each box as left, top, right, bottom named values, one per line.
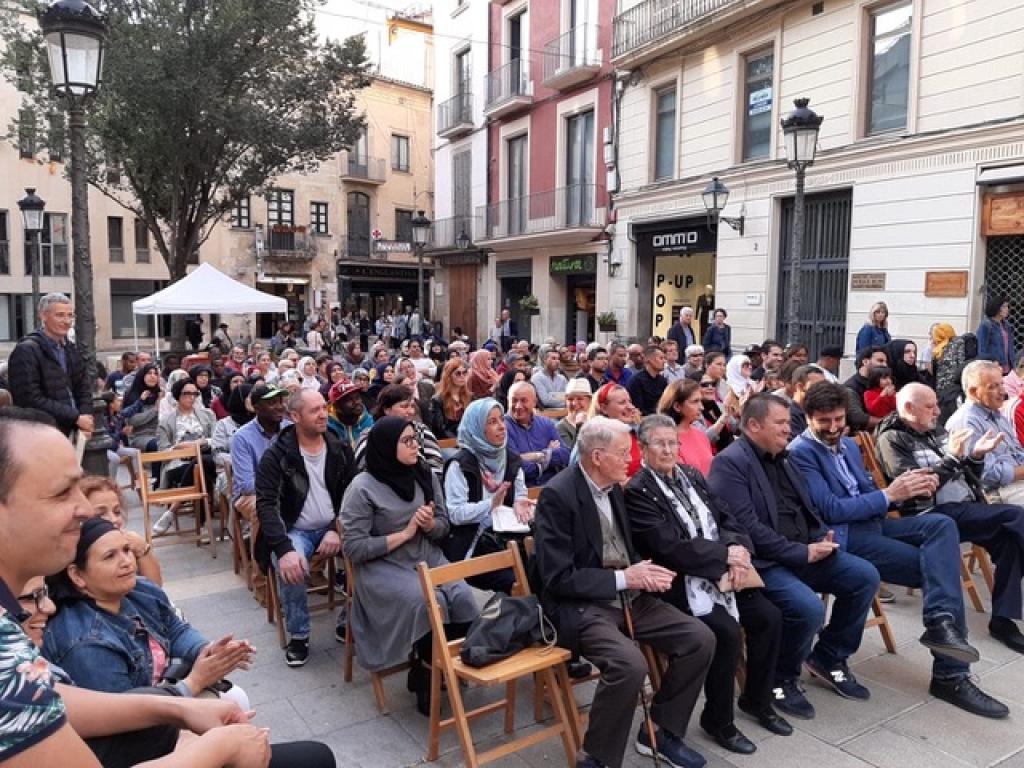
left=626, top=414, right=793, bottom=755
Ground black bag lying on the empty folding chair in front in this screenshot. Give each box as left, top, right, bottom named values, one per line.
left=460, top=593, right=558, bottom=667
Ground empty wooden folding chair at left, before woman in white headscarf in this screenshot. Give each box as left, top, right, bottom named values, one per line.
left=138, top=443, right=217, bottom=557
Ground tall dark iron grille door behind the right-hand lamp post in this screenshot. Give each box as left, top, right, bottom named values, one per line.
left=775, top=190, right=853, bottom=360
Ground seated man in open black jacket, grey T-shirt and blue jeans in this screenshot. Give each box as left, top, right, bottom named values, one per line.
left=256, top=389, right=352, bottom=667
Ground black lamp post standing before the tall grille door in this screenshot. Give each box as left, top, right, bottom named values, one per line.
left=782, top=98, right=824, bottom=344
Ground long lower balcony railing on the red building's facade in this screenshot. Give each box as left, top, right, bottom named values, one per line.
left=477, top=184, right=605, bottom=240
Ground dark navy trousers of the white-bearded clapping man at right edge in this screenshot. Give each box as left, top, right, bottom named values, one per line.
left=930, top=503, right=1024, bottom=618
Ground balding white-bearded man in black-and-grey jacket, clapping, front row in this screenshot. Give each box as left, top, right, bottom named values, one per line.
left=878, top=382, right=1024, bottom=653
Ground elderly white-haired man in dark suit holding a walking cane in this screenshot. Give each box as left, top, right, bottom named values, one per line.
left=536, top=417, right=715, bottom=768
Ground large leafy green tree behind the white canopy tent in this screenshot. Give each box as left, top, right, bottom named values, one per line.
left=0, top=0, right=370, bottom=348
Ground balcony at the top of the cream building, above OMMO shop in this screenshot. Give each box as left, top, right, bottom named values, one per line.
left=611, top=0, right=741, bottom=62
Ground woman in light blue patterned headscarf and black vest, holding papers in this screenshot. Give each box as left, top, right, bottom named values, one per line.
left=441, top=397, right=535, bottom=592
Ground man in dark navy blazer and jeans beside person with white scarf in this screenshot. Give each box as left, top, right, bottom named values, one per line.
left=708, top=393, right=879, bottom=719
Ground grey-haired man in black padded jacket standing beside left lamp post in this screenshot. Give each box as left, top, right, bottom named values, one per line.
left=7, top=293, right=93, bottom=435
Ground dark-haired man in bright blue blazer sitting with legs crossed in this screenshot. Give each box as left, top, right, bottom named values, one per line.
left=790, top=382, right=1009, bottom=718
